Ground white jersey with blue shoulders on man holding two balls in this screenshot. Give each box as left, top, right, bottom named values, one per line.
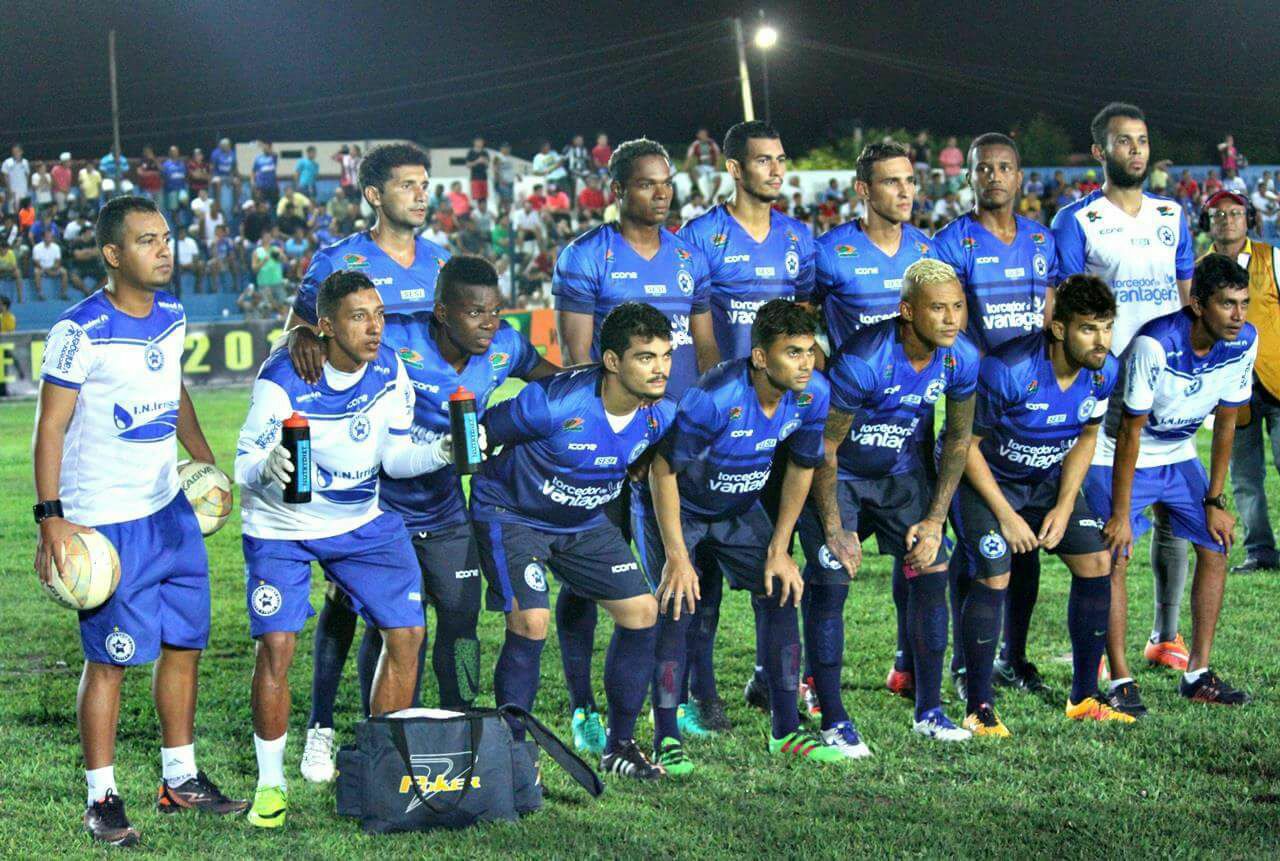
left=40, top=290, right=187, bottom=526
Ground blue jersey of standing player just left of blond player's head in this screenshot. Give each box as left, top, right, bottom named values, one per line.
left=813, top=219, right=933, bottom=351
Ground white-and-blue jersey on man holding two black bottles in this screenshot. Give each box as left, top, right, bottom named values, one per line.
left=236, top=344, right=420, bottom=540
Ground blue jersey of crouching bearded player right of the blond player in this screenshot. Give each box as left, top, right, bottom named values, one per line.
left=973, top=331, right=1120, bottom=484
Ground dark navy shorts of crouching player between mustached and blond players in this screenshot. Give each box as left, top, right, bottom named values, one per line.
left=631, top=500, right=773, bottom=595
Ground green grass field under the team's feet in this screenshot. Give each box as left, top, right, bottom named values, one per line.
left=0, top=389, right=1280, bottom=858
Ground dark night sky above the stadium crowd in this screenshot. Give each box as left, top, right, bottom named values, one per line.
left=0, top=0, right=1280, bottom=159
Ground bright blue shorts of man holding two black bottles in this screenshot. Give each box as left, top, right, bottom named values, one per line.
left=241, top=513, right=424, bottom=637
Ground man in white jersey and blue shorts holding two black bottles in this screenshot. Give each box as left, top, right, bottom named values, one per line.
left=236, top=271, right=452, bottom=828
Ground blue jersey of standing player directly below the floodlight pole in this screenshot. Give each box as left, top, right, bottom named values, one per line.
left=680, top=205, right=814, bottom=359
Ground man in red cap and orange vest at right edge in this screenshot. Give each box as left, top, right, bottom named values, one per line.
left=1202, top=191, right=1280, bottom=574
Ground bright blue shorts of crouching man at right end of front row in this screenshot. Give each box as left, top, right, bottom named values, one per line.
left=1084, top=458, right=1226, bottom=554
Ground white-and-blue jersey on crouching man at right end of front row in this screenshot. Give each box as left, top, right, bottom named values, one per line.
left=1093, top=310, right=1258, bottom=470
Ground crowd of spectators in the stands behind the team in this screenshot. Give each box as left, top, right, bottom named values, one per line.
left=0, top=129, right=1280, bottom=326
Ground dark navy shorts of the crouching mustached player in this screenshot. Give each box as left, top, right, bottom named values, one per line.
left=475, top=521, right=653, bottom=613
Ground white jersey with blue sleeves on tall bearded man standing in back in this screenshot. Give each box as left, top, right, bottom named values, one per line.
left=1053, top=189, right=1196, bottom=356
